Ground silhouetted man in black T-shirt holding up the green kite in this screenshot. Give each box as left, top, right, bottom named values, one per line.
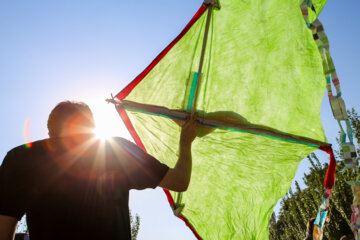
left=0, top=101, right=196, bottom=240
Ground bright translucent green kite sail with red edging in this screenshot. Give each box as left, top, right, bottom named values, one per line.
left=110, top=0, right=336, bottom=239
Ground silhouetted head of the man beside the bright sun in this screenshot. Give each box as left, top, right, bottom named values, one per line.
left=47, top=101, right=95, bottom=137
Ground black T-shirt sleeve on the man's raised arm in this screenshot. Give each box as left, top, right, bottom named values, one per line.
left=116, top=139, right=169, bottom=190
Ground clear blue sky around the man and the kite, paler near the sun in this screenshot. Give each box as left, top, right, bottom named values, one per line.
left=0, top=0, right=360, bottom=240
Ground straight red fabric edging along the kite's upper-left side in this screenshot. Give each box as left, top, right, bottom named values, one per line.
left=115, top=5, right=207, bottom=101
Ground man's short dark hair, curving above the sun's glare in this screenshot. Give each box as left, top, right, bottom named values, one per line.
left=47, top=101, right=95, bottom=137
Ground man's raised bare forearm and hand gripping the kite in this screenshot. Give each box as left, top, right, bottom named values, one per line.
left=159, top=115, right=197, bottom=192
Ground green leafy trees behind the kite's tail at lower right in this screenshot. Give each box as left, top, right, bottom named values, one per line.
left=269, top=109, right=360, bottom=240
